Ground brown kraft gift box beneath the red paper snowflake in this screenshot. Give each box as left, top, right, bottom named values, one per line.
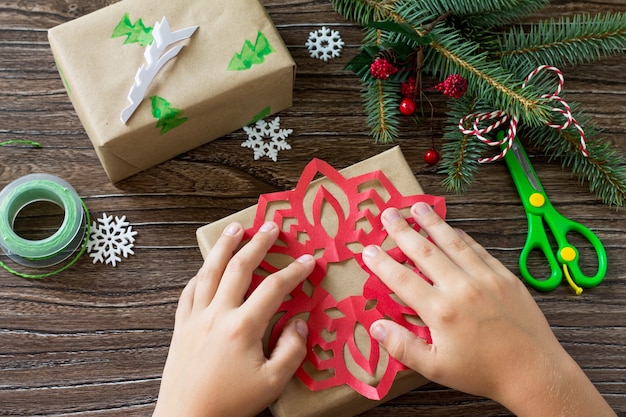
left=197, top=147, right=427, bottom=417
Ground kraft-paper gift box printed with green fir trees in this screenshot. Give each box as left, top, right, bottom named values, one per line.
left=48, top=0, right=295, bottom=182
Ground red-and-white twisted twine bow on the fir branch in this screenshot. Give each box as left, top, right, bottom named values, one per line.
left=459, top=65, right=589, bottom=164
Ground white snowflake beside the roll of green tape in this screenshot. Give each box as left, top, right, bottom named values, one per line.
left=87, top=213, right=137, bottom=266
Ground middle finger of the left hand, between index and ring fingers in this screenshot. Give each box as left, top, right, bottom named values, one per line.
left=214, top=222, right=279, bottom=308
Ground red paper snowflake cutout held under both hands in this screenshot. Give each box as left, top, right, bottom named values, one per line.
left=246, top=159, right=446, bottom=400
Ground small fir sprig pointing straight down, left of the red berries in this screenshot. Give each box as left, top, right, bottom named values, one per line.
left=363, top=80, right=400, bottom=144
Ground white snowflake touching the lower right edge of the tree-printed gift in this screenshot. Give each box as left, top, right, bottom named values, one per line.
left=241, top=117, right=293, bottom=162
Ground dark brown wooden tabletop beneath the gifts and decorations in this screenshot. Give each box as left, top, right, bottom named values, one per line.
left=0, top=0, right=626, bottom=417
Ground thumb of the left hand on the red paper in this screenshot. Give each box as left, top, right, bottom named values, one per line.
left=264, top=319, right=309, bottom=394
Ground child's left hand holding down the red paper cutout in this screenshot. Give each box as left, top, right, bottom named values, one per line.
left=154, top=223, right=315, bottom=417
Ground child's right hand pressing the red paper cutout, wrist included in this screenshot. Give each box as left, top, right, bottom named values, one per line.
left=363, top=203, right=615, bottom=417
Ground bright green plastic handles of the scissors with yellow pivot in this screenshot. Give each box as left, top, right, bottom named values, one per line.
left=519, top=207, right=607, bottom=291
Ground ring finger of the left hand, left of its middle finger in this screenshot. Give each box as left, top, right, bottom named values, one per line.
left=193, top=223, right=243, bottom=310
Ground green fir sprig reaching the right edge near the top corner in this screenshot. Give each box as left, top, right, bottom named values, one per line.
left=498, top=13, right=626, bottom=72
